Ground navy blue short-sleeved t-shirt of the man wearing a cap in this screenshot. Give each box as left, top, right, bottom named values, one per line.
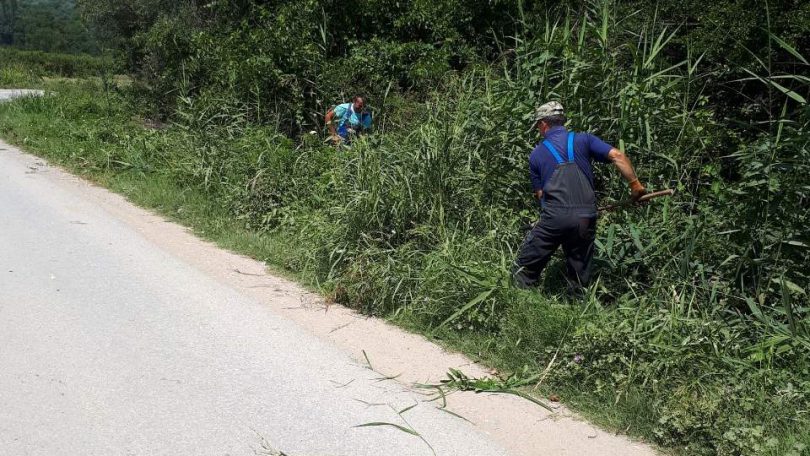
left=529, top=127, right=613, bottom=192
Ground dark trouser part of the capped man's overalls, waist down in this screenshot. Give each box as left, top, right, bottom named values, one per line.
left=514, top=208, right=596, bottom=289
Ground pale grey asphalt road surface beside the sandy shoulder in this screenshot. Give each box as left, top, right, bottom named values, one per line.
left=0, top=142, right=506, bottom=456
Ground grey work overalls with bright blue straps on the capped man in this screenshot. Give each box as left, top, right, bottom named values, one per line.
left=515, top=132, right=596, bottom=288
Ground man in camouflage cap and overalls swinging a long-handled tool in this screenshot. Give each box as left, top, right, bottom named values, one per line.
left=514, top=101, right=646, bottom=290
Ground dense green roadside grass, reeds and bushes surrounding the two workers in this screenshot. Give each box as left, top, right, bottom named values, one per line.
left=0, top=0, right=810, bottom=455
